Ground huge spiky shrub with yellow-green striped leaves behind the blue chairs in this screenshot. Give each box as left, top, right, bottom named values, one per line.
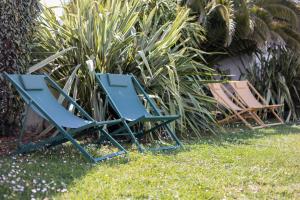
left=29, top=0, right=214, bottom=137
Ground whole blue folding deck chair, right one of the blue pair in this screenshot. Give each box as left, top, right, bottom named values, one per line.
left=96, top=74, right=183, bottom=152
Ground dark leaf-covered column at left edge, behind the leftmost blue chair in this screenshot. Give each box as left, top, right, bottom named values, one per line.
left=0, top=0, right=39, bottom=135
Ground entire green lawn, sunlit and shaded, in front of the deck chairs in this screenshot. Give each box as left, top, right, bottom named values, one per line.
left=0, top=126, right=300, bottom=199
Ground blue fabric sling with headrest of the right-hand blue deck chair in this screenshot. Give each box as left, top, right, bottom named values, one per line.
left=96, top=74, right=150, bottom=121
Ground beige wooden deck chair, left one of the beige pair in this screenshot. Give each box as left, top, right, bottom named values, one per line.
left=208, top=83, right=266, bottom=129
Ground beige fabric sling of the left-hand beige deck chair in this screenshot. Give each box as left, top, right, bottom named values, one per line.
left=208, top=83, right=242, bottom=111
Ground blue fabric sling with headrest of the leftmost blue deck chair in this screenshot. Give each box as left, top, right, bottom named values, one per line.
left=6, top=74, right=90, bottom=128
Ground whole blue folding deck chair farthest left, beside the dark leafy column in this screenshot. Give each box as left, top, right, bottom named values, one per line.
left=4, top=73, right=126, bottom=162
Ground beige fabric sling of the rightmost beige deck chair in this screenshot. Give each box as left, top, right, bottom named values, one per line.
left=229, top=81, right=263, bottom=108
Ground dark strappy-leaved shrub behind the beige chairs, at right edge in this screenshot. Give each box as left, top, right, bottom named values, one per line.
left=247, top=47, right=300, bottom=121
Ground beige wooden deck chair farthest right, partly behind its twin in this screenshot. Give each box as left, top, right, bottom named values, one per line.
left=229, top=81, right=284, bottom=126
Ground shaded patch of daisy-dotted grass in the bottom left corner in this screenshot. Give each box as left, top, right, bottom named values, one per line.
left=0, top=143, right=130, bottom=199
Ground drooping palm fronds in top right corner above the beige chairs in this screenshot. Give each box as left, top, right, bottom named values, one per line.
left=181, top=0, right=300, bottom=54
